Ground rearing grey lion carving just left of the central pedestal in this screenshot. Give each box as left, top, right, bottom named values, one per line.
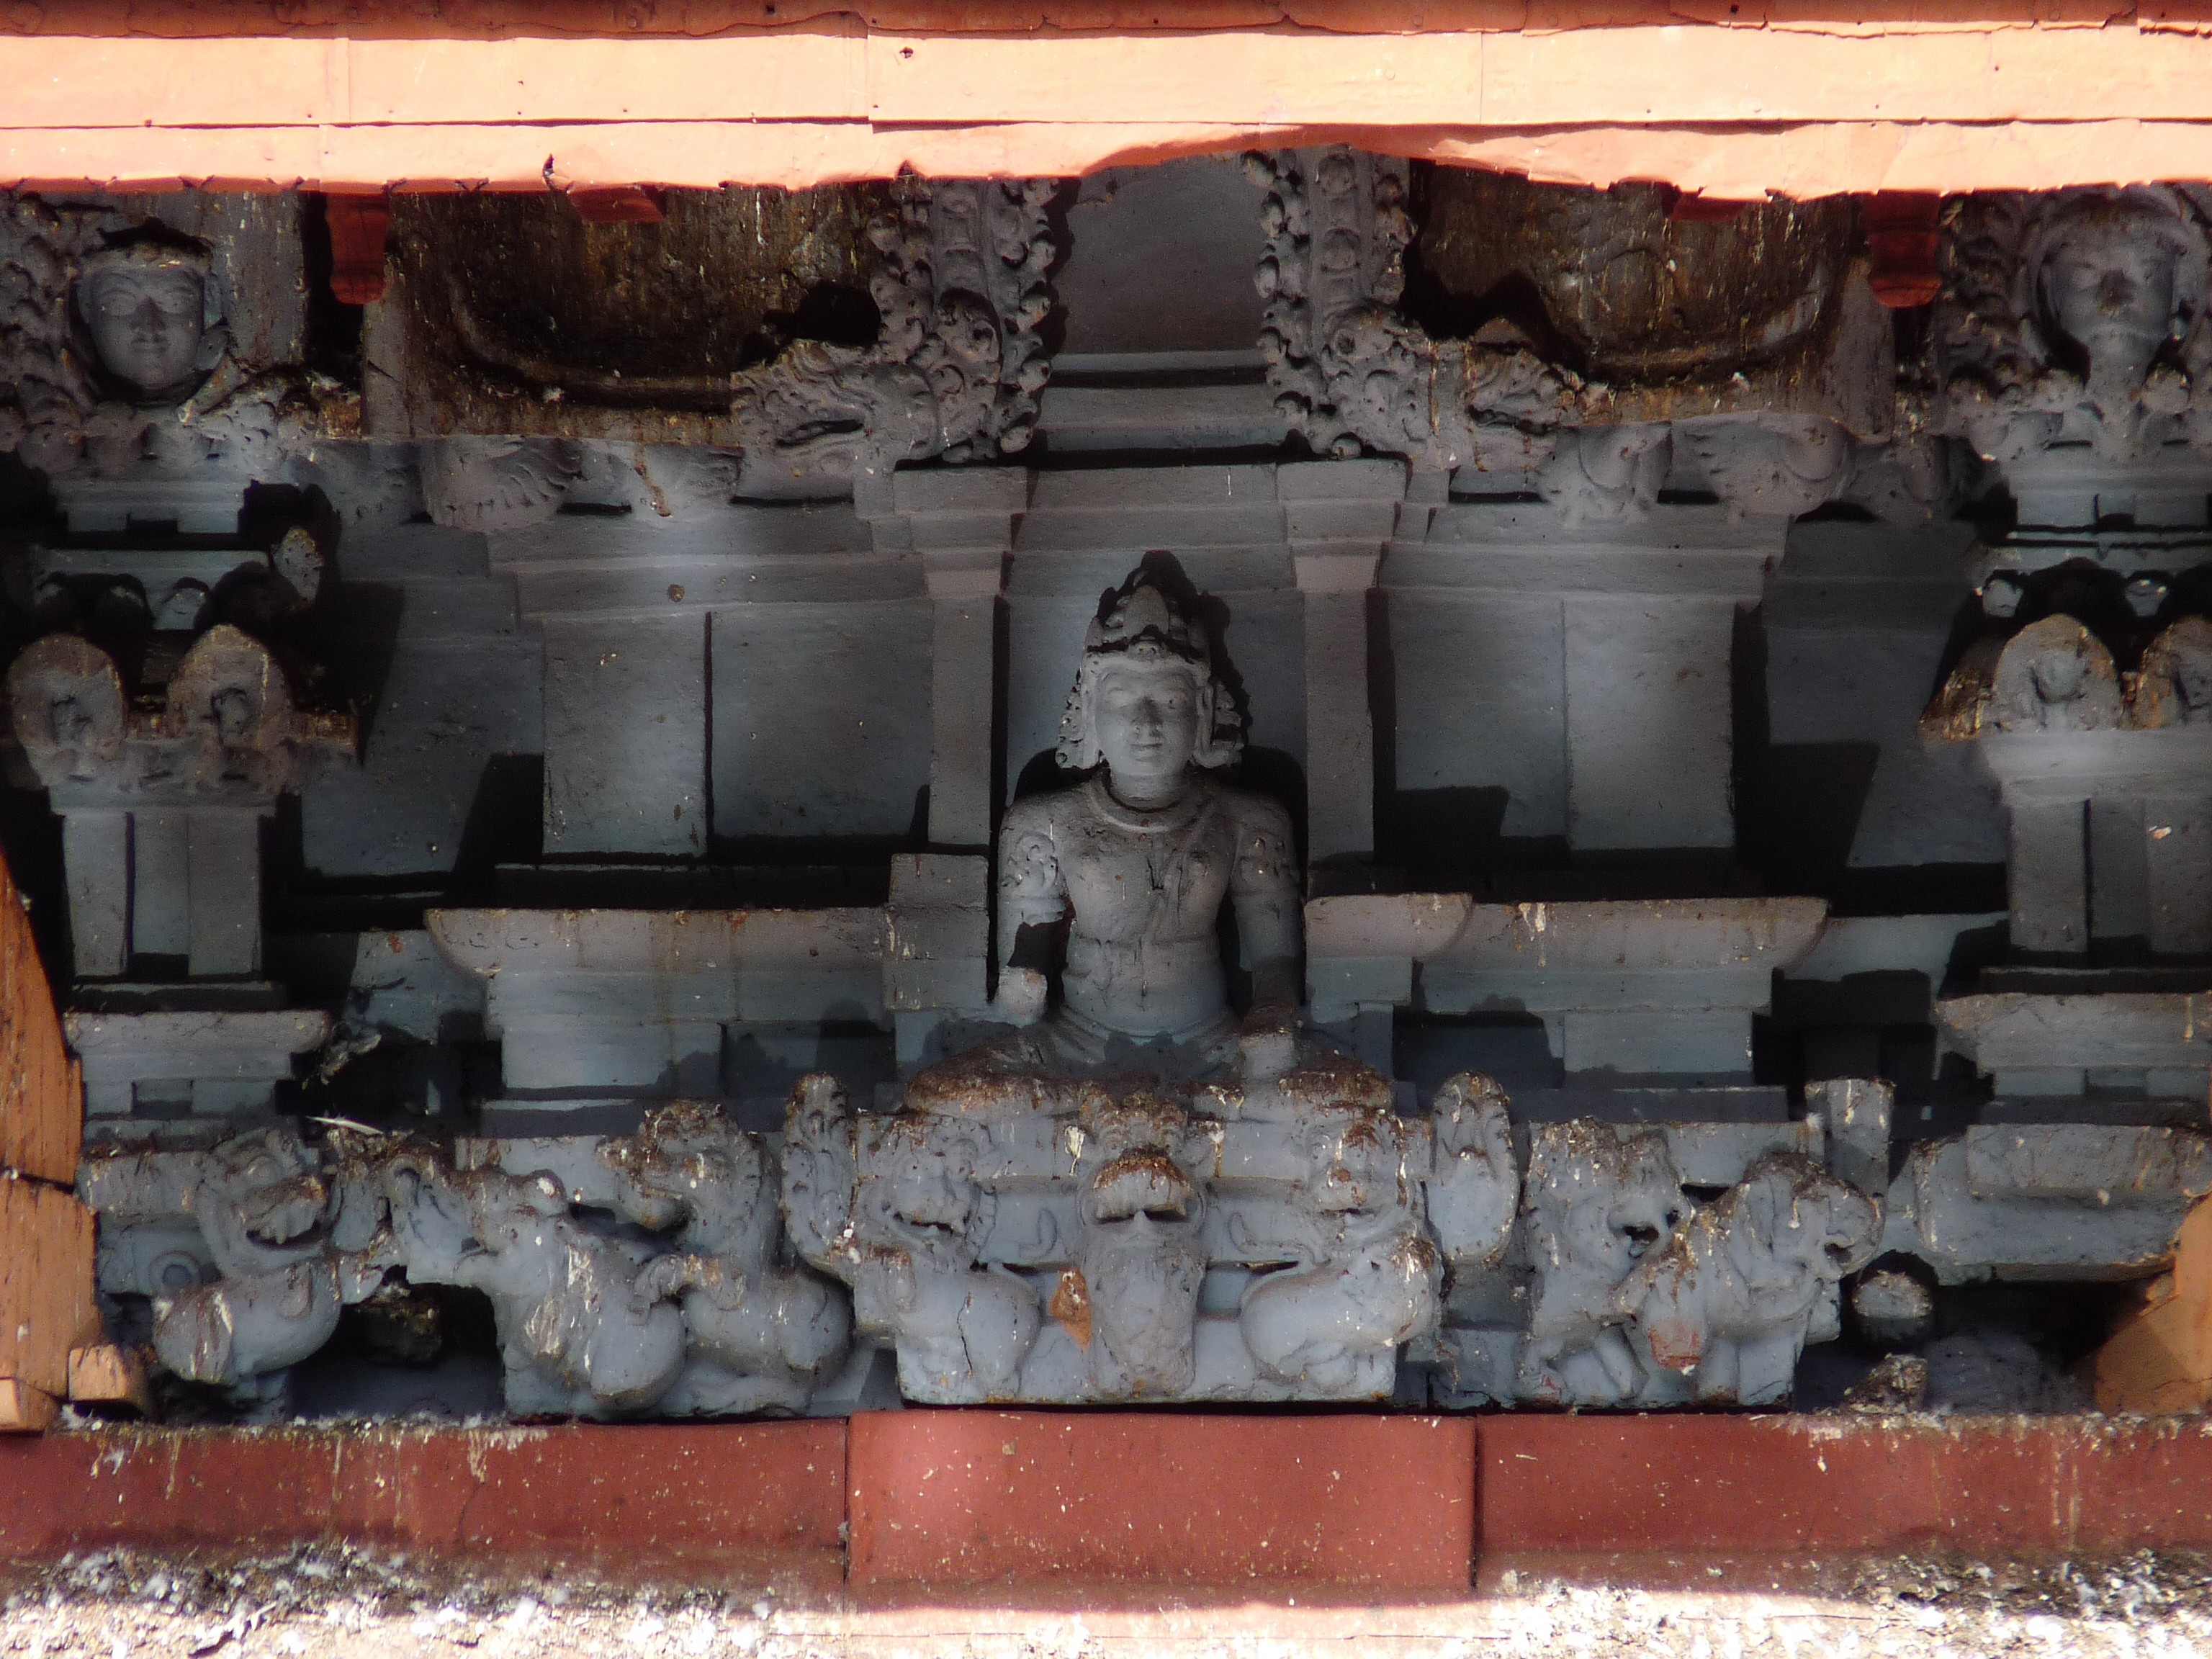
left=597, top=1102, right=852, bottom=1416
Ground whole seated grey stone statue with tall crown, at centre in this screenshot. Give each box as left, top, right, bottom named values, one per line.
left=907, top=571, right=1300, bottom=1110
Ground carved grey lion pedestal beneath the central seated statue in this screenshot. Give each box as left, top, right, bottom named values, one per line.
left=786, top=1073, right=1517, bottom=1405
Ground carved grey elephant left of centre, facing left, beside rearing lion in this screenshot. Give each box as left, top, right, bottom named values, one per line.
left=385, top=1157, right=685, bottom=1418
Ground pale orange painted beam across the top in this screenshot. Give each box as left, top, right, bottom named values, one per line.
left=0, top=18, right=2212, bottom=197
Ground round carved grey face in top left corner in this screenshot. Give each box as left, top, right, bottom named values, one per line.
left=75, top=241, right=230, bottom=405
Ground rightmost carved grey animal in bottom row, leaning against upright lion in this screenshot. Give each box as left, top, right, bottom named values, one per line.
left=1612, top=1153, right=1882, bottom=1405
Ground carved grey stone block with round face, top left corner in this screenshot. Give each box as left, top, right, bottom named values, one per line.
left=0, top=192, right=359, bottom=482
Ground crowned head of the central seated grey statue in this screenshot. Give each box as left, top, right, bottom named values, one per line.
left=1057, top=571, right=1243, bottom=776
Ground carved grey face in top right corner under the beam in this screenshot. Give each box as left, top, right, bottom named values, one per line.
left=2022, top=186, right=2212, bottom=405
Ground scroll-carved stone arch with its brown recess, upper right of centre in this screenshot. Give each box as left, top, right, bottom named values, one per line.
left=1248, top=146, right=1911, bottom=522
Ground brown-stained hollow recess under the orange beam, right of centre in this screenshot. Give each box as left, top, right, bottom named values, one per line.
left=1405, top=163, right=1858, bottom=421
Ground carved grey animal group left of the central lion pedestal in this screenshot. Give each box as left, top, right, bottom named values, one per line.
left=80, top=1102, right=852, bottom=1416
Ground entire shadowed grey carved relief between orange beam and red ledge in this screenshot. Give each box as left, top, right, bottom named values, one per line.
left=13, top=159, right=2212, bottom=1451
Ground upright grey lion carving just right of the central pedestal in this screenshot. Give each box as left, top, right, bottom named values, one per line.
left=1517, top=1122, right=1690, bottom=1405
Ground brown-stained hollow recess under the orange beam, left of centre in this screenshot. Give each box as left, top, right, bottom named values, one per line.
left=369, top=184, right=894, bottom=442
